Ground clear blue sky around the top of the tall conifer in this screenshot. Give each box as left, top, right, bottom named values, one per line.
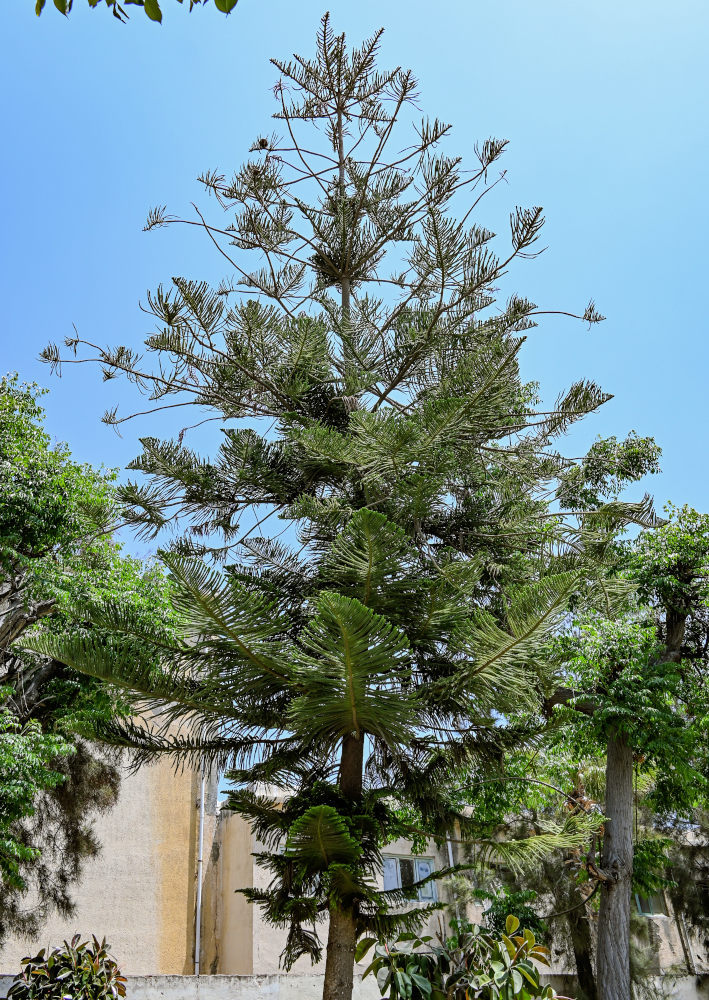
left=0, top=0, right=709, bottom=556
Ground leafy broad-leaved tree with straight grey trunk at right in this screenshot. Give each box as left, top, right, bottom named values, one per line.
left=536, top=507, right=709, bottom=1000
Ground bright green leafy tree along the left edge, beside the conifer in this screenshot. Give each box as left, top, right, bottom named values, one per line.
left=0, top=376, right=166, bottom=940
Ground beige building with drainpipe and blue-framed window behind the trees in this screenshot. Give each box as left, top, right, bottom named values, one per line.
left=0, top=763, right=709, bottom=996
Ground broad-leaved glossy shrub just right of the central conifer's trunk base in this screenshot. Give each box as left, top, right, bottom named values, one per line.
left=357, top=916, right=568, bottom=1000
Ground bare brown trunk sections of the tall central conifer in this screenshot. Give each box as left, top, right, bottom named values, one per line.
left=323, top=734, right=364, bottom=1000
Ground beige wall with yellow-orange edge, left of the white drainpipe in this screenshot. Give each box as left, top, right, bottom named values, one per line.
left=0, top=762, right=209, bottom=975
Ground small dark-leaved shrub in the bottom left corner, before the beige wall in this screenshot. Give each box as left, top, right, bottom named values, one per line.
left=7, top=934, right=126, bottom=1000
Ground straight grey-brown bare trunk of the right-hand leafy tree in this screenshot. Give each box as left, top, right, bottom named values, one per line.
left=597, top=734, right=633, bottom=1000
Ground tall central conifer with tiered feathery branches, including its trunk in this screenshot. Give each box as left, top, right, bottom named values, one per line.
left=26, top=17, right=650, bottom=1000
